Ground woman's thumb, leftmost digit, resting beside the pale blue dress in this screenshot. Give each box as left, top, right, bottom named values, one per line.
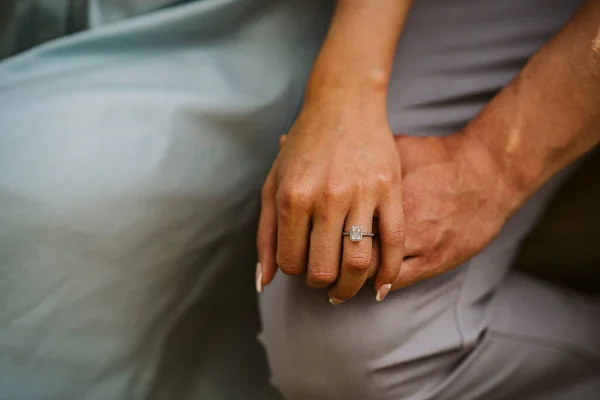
left=255, top=179, right=277, bottom=293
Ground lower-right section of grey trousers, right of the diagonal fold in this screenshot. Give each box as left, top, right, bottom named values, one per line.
left=431, top=273, right=600, bottom=400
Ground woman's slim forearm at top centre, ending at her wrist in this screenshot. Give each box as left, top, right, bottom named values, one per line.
left=305, top=0, right=411, bottom=109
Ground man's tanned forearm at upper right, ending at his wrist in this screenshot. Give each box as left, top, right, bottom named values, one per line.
left=465, top=0, right=600, bottom=206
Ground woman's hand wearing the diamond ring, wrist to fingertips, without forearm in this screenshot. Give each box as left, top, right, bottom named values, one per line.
left=257, top=100, right=404, bottom=304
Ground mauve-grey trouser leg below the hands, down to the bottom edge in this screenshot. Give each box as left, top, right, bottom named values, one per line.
left=260, top=242, right=600, bottom=400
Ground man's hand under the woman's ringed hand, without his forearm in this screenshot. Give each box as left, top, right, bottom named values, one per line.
left=386, top=133, right=515, bottom=290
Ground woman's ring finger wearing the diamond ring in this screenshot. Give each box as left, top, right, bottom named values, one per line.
left=329, top=200, right=374, bottom=304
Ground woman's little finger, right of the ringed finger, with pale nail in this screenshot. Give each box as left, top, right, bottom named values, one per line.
left=375, top=196, right=404, bottom=301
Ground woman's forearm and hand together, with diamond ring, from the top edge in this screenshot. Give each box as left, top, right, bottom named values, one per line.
left=256, top=0, right=411, bottom=304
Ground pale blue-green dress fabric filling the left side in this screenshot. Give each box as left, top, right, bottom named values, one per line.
left=0, top=0, right=329, bottom=400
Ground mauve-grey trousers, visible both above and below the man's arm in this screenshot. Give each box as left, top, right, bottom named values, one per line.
left=260, top=0, right=600, bottom=400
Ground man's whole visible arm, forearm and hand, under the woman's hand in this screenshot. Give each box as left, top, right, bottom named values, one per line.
left=360, top=0, right=600, bottom=289
